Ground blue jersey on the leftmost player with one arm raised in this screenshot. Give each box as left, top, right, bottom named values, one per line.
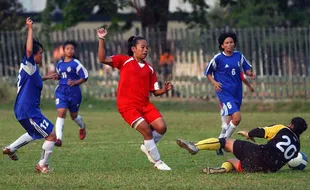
left=14, top=54, right=43, bottom=121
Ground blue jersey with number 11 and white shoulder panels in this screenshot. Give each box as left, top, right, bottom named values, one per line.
left=56, top=59, right=88, bottom=85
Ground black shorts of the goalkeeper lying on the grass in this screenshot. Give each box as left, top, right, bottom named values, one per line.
left=233, top=140, right=270, bottom=172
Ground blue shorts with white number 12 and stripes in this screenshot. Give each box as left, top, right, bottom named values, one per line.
left=19, top=115, right=54, bottom=139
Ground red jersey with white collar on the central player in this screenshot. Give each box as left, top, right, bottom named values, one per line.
left=111, top=55, right=159, bottom=110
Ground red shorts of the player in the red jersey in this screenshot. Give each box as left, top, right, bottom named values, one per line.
left=119, top=103, right=162, bottom=126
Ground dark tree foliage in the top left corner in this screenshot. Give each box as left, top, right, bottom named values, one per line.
left=0, top=0, right=25, bottom=30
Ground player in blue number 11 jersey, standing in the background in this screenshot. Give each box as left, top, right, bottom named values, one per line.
left=55, top=41, right=88, bottom=146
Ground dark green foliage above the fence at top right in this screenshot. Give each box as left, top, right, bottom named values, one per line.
left=217, top=0, right=310, bottom=27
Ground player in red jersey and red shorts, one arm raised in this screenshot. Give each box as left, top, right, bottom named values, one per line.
left=97, top=28, right=173, bottom=170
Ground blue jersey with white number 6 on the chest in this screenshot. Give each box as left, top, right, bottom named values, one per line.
left=205, top=51, right=252, bottom=105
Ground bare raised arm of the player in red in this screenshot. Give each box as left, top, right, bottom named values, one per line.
left=97, top=28, right=112, bottom=66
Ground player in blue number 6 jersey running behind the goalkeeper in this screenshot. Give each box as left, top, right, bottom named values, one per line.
left=205, top=33, right=255, bottom=140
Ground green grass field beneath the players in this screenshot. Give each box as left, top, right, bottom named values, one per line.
left=0, top=102, right=310, bottom=189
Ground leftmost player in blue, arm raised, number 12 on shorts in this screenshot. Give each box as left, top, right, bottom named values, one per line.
left=3, top=17, right=58, bottom=173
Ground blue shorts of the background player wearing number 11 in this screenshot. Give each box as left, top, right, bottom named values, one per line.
left=55, top=85, right=82, bottom=112
